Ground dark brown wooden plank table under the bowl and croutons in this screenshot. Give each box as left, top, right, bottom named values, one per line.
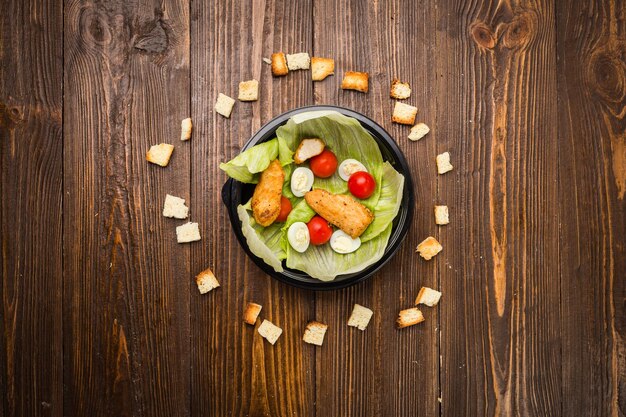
left=0, top=0, right=626, bottom=416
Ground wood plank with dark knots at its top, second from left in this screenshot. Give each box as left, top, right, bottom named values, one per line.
left=64, top=0, right=194, bottom=416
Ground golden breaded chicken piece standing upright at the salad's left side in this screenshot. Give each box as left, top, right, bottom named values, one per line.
left=252, top=159, right=285, bottom=227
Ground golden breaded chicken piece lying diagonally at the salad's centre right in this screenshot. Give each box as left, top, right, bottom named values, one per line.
left=304, top=190, right=374, bottom=239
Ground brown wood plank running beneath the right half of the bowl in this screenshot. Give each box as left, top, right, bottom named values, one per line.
left=313, top=0, right=438, bottom=416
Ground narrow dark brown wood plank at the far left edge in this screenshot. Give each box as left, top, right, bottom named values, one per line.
left=0, top=1, right=63, bottom=416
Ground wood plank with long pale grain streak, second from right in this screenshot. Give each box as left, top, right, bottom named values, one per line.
left=433, top=1, right=562, bottom=416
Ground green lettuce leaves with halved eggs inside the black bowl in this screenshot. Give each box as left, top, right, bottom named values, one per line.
left=220, top=111, right=404, bottom=281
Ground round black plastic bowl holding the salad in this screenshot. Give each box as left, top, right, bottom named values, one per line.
left=222, top=106, right=415, bottom=290
